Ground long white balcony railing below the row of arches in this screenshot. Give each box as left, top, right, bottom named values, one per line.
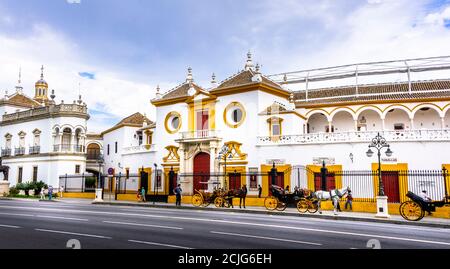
left=257, top=129, right=450, bottom=146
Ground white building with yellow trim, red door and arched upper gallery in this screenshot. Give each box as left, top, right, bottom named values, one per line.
left=97, top=53, right=450, bottom=205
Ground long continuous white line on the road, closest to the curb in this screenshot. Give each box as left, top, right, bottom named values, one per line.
left=0, top=203, right=450, bottom=245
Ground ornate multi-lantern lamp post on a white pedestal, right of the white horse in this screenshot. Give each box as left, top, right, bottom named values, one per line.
left=366, top=133, right=393, bottom=217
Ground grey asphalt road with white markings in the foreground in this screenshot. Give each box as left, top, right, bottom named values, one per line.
left=0, top=200, right=450, bottom=249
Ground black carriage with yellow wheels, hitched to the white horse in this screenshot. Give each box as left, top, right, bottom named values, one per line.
left=264, top=185, right=318, bottom=213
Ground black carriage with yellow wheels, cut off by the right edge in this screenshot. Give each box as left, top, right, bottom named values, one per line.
left=400, top=191, right=450, bottom=221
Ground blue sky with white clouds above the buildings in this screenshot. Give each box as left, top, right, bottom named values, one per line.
left=0, top=0, right=450, bottom=132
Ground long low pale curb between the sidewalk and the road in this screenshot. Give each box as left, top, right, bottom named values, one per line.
left=92, top=202, right=450, bottom=229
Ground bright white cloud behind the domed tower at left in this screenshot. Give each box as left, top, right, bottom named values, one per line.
left=0, top=24, right=156, bottom=132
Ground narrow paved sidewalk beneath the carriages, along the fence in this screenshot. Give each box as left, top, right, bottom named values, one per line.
left=92, top=200, right=450, bottom=228
